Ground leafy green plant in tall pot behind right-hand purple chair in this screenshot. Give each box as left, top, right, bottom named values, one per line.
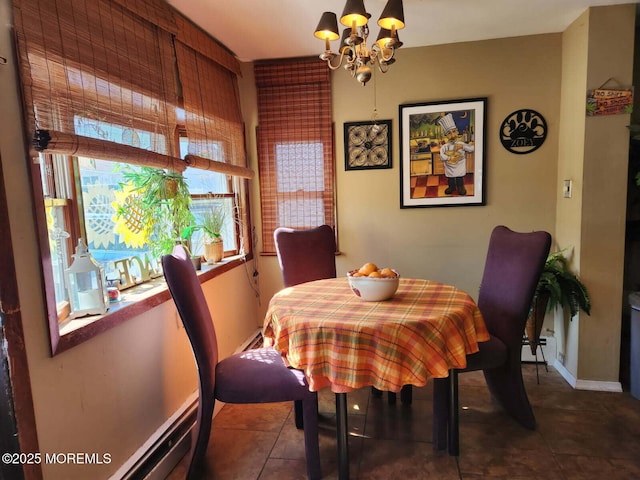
left=526, top=250, right=591, bottom=355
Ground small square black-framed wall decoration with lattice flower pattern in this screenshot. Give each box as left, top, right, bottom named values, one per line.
left=344, top=120, right=392, bottom=170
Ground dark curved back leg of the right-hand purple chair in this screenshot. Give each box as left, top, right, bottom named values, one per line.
left=484, top=358, right=536, bottom=430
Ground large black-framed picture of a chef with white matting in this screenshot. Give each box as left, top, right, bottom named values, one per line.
left=399, top=98, right=487, bottom=208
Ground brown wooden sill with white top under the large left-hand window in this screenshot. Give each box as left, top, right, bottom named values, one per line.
left=51, top=254, right=252, bottom=355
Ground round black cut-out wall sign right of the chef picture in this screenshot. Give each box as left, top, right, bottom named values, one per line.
left=500, top=108, right=547, bottom=155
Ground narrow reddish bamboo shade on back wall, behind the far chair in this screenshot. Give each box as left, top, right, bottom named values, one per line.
left=254, top=58, right=335, bottom=253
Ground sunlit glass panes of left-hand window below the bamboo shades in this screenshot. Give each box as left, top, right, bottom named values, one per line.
left=42, top=155, right=241, bottom=322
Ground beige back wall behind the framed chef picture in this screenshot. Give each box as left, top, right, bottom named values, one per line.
left=248, top=34, right=561, bottom=313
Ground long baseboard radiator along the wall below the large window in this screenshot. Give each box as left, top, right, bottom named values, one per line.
left=110, top=330, right=263, bottom=480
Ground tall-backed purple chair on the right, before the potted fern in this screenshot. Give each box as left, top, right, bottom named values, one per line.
left=433, top=226, right=551, bottom=456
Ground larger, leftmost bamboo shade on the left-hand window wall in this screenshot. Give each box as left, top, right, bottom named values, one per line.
left=14, top=0, right=179, bottom=168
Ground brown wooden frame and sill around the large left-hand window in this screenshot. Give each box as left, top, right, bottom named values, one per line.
left=31, top=133, right=253, bottom=356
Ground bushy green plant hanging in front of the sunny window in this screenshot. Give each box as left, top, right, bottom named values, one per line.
left=116, top=166, right=194, bottom=257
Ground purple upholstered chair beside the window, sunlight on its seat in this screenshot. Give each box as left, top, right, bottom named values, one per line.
left=162, top=246, right=321, bottom=480
